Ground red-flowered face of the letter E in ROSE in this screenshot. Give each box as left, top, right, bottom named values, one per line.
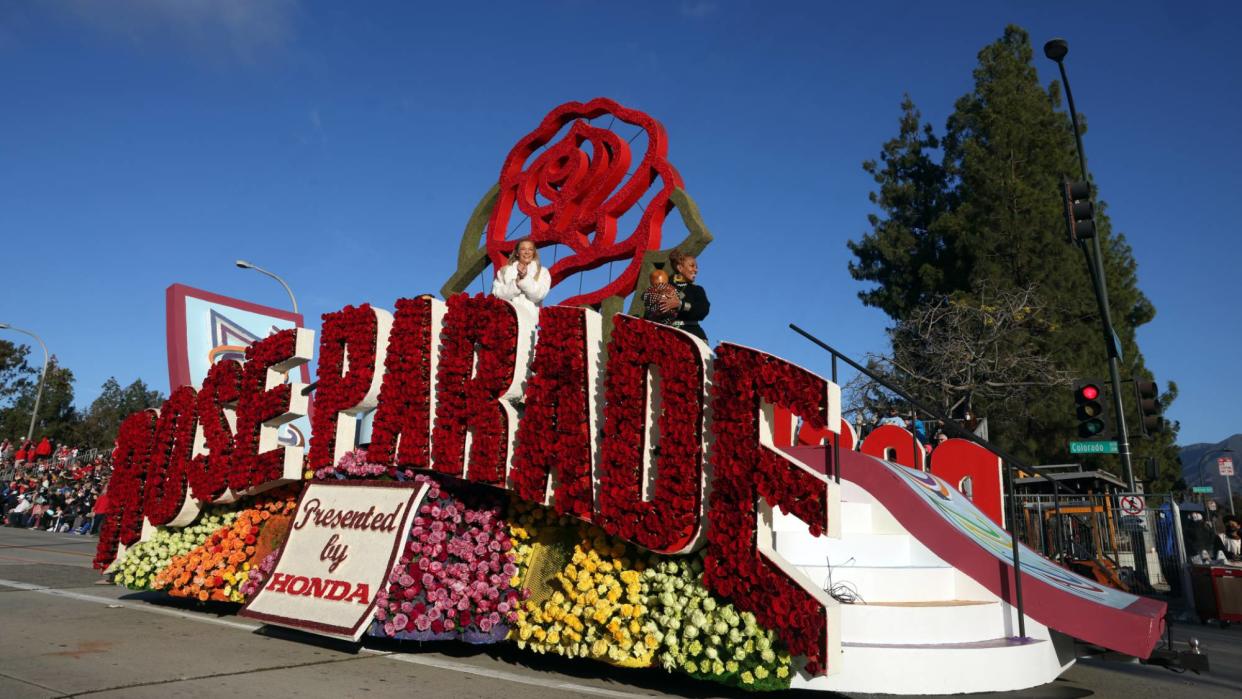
left=229, top=329, right=297, bottom=492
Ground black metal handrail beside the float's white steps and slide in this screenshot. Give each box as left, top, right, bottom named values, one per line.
left=789, top=323, right=1078, bottom=638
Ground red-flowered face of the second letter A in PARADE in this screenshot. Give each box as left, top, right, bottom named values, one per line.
left=509, top=305, right=594, bottom=520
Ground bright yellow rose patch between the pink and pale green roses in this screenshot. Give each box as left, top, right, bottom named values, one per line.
left=509, top=503, right=658, bottom=667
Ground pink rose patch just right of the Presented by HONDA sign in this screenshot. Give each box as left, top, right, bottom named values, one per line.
left=370, top=474, right=522, bottom=643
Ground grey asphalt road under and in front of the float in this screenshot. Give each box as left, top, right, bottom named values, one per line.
left=0, top=528, right=1242, bottom=699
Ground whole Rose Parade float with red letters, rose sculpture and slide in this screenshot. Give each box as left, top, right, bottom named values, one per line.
left=96, top=99, right=1164, bottom=694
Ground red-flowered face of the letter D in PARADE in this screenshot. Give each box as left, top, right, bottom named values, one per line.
left=599, top=315, right=705, bottom=552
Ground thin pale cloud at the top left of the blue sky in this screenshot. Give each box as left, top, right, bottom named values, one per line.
left=58, top=0, right=299, bottom=62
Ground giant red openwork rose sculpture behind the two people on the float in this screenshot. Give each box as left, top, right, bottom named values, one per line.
left=487, top=97, right=682, bottom=305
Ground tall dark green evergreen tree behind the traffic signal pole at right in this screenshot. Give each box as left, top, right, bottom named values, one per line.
left=850, top=26, right=1176, bottom=486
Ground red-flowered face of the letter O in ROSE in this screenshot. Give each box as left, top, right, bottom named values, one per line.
left=143, top=386, right=197, bottom=526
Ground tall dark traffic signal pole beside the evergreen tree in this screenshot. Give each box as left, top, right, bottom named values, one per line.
left=1043, top=38, right=1136, bottom=493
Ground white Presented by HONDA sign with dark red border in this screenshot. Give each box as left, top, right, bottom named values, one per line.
left=240, top=480, right=427, bottom=641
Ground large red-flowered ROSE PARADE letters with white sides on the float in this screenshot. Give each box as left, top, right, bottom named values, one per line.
left=96, top=294, right=998, bottom=672
